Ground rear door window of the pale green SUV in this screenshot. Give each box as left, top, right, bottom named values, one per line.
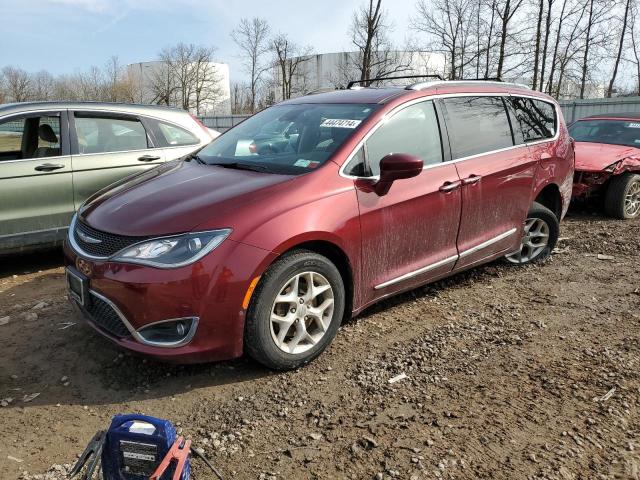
left=75, top=114, right=148, bottom=154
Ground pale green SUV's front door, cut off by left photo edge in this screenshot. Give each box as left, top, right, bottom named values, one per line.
left=0, top=111, right=74, bottom=249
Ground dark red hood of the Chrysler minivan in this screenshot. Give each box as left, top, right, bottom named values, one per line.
left=79, top=161, right=295, bottom=236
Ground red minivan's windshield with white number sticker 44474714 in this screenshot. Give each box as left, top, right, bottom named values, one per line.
left=195, top=104, right=377, bottom=175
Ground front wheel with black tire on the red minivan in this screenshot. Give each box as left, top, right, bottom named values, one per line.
left=244, top=250, right=345, bottom=370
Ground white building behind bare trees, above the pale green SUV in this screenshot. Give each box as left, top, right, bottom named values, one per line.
left=127, top=61, right=231, bottom=115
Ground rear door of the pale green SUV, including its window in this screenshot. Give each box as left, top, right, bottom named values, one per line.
left=71, top=111, right=165, bottom=208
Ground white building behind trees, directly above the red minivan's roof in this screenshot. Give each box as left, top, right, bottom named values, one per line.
left=274, top=51, right=445, bottom=101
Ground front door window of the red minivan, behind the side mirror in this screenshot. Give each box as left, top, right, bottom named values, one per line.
left=366, top=101, right=442, bottom=175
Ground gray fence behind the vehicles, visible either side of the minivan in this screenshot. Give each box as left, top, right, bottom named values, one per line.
left=200, top=97, right=640, bottom=132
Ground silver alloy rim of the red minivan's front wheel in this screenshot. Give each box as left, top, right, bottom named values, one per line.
left=270, top=272, right=334, bottom=354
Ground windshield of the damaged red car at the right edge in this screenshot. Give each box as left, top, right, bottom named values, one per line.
left=569, top=120, right=640, bottom=148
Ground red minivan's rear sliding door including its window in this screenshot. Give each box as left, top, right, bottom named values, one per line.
left=443, top=96, right=537, bottom=269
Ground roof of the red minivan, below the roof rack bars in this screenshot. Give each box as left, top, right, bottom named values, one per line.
left=281, top=80, right=553, bottom=105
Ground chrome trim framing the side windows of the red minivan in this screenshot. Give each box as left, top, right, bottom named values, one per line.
left=338, top=91, right=560, bottom=180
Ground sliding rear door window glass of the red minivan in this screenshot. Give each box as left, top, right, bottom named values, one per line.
left=444, top=97, right=513, bottom=159
